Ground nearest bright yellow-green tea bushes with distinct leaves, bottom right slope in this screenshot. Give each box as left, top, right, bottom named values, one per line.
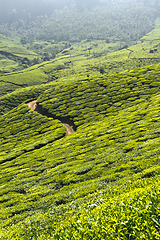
left=0, top=172, right=160, bottom=240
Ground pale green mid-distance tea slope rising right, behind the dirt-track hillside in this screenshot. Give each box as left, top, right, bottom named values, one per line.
left=0, top=17, right=160, bottom=95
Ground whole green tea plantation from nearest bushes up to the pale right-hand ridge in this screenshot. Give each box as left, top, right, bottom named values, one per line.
left=0, top=17, right=160, bottom=240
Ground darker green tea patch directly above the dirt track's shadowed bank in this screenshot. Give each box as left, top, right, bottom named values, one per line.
left=37, top=65, right=160, bottom=126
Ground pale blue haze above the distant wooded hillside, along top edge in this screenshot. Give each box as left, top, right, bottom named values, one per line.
left=0, top=0, right=160, bottom=24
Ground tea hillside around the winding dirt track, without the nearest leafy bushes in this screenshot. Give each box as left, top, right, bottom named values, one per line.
left=0, top=65, right=160, bottom=236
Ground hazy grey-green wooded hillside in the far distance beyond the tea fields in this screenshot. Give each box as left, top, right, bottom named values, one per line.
left=0, top=1, right=156, bottom=43
